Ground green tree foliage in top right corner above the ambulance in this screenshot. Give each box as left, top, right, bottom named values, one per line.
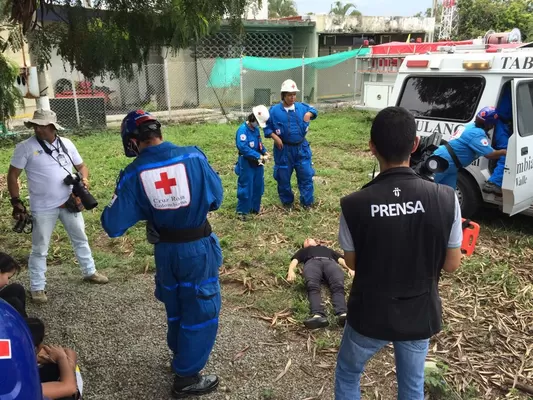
left=457, top=0, right=533, bottom=40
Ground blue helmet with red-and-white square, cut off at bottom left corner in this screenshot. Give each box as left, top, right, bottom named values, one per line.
left=0, top=299, right=43, bottom=400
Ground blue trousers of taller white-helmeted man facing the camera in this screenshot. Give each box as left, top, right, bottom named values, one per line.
left=274, top=140, right=315, bottom=206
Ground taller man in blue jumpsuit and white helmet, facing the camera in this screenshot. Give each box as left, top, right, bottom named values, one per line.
left=264, top=79, right=318, bottom=208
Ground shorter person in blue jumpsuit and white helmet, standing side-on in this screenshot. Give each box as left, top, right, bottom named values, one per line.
left=235, top=105, right=270, bottom=219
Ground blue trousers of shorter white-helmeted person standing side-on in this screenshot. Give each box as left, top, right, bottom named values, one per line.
left=235, top=156, right=265, bottom=214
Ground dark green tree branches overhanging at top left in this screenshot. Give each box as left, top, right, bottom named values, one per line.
left=0, top=0, right=255, bottom=79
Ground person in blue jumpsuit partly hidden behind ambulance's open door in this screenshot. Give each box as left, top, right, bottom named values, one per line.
left=483, top=85, right=513, bottom=196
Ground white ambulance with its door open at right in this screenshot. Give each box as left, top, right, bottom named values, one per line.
left=389, top=45, right=533, bottom=218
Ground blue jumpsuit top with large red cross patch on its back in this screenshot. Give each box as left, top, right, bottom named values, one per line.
left=101, top=142, right=223, bottom=237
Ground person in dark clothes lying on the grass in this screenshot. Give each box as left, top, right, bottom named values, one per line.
left=287, top=238, right=354, bottom=329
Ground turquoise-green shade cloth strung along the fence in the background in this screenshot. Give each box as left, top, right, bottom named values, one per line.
left=207, top=48, right=371, bottom=88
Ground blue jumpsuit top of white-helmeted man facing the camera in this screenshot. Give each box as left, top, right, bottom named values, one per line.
left=264, top=102, right=318, bottom=144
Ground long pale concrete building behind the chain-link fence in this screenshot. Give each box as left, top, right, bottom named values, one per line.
left=3, top=4, right=435, bottom=126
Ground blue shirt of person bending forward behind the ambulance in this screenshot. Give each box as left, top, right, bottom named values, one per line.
left=433, top=123, right=494, bottom=168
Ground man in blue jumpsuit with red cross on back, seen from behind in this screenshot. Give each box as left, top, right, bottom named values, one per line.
left=101, top=110, right=223, bottom=398
